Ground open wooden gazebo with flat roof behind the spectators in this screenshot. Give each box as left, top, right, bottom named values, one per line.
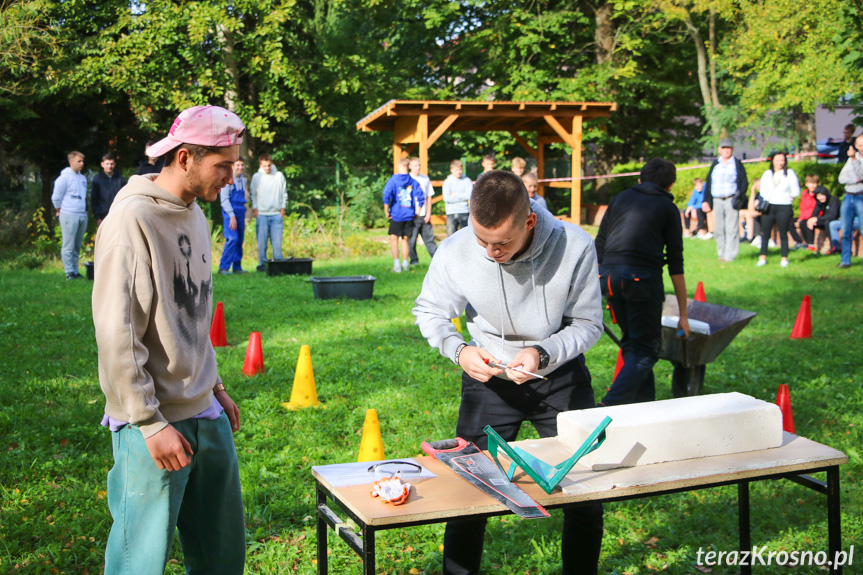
left=357, top=100, right=617, bottom=223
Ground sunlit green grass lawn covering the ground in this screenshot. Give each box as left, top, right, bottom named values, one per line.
left=0, top=235, right=863, bottom=575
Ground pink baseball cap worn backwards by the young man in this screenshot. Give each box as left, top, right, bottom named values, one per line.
left=144, top=106, right=246, bottom=158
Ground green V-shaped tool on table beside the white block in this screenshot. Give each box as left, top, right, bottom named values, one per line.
left=483, top=416, right=611, bottom=494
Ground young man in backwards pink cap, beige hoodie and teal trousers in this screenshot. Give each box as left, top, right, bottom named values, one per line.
left=93, top=106, right=245, bottom=575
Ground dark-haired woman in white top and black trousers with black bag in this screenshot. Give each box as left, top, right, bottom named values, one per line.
left=756, top=152, right=800, bottom=268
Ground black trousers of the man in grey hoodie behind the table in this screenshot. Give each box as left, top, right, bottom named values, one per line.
left=443, top=355, right=602, bottom=575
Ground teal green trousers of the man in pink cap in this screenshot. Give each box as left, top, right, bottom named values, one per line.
left=105, top=413, right=246, bottom=575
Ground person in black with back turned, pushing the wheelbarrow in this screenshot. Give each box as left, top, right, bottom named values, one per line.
left=596, top=158, right=689, bottom=405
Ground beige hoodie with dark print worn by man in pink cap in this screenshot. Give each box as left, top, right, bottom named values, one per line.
left=93, top=174, right=221, bottom=438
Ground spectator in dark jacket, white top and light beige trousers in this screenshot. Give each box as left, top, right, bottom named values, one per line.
left=701, top=138, right=749, bottom=262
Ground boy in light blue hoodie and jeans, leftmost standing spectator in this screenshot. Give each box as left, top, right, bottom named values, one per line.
left=51, top=152, right=87, bottom=280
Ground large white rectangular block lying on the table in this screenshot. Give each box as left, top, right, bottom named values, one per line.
left=557, top=392, right=782, bottom=471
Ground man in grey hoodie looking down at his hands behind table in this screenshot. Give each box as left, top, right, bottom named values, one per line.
left=413, top=170, right=602, bottom=575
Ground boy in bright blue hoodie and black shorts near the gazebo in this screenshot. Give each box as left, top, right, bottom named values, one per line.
left=384, top=158, right=425, bottom=273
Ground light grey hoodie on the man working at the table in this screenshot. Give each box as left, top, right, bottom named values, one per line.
left=413, top=202, right=602, bottom=379
